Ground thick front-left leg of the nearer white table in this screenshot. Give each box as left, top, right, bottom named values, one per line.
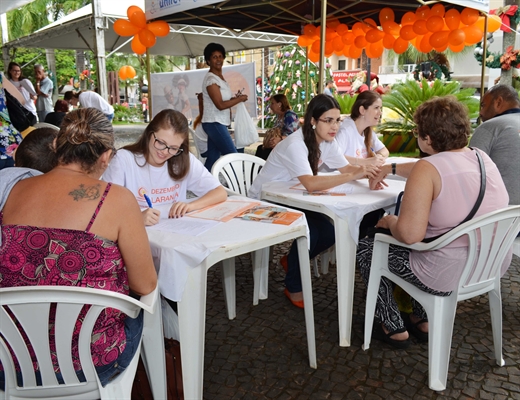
left=177, top=263, right=207, bottom=399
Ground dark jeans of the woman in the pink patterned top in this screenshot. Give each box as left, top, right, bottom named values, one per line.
left=0, top=310, right=143, bottom=390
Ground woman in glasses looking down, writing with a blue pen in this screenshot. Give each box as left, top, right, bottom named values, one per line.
left=103, top=109, right=227, bottom=225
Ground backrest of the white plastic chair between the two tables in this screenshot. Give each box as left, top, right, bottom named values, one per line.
left=211, top=153, right=265, bottom=196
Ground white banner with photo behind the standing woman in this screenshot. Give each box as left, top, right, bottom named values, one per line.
left=151, top=63, right=257, bottom=121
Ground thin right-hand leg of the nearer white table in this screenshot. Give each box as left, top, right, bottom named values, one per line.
left=296, top=236, right=318, bottom=368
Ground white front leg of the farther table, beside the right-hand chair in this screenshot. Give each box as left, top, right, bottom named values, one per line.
left=334, top=217, right=357, bottom=347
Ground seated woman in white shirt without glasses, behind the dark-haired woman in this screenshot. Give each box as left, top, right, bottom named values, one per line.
left=336, top=90, right=390, bottom=166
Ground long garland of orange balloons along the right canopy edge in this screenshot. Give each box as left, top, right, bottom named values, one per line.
left=298, top=3, right=501, bottom=62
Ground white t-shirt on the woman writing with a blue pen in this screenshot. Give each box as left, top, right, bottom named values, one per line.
left=102, top=150, right=220, bottom=208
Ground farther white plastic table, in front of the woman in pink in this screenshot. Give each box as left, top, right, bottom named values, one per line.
left=261, top=180, right=405, bottom=347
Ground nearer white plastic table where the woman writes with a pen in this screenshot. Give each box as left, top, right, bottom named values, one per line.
left=147, top=200, right=317, bottom=399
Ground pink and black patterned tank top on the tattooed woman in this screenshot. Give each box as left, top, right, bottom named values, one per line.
left=0, top=183, right=129, bottom=371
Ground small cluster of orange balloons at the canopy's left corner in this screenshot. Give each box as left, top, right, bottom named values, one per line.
left=114, top=6, right=170, bottom=54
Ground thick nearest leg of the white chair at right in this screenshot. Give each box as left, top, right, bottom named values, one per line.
left=426, top=295, right=457, bottom=391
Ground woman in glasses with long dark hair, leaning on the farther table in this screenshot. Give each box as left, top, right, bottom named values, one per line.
left=249, top=94, right=379, bottom=308
